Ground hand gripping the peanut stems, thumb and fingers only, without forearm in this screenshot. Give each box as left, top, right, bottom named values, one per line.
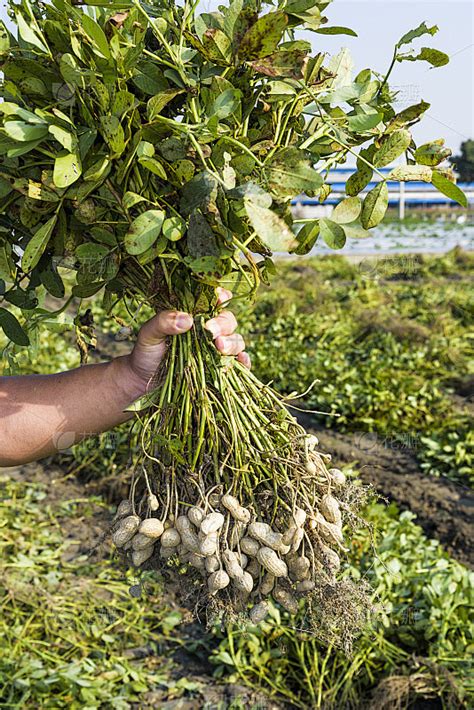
left=127, top=288, right=250, bottom=388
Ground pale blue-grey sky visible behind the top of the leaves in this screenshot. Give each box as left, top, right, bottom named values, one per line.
left=0, top=0, right=474, bottom=152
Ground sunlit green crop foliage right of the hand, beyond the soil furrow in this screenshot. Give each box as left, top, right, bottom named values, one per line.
left=240, top=250, right=474, bottom=490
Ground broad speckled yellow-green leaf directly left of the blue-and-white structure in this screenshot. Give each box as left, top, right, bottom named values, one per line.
left=266, top=148, right=323, bottom=198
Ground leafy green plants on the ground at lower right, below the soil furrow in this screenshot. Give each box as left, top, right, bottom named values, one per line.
left=213, top=505, right=474, bottom=708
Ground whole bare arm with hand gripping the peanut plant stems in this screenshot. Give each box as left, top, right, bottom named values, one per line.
left=0, top=292, right=249, bottom=466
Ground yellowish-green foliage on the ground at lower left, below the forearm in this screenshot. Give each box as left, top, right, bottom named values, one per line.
left=0, top=476, right=193, bottom=710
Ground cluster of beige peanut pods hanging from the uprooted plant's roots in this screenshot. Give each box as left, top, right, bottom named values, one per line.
left=112, top=468, right=345, bottom=623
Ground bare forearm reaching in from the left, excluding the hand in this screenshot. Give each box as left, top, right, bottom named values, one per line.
left=0, top=357, right=145, bottom=466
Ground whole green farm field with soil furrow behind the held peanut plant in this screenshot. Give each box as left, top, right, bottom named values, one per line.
left=0, top=249, right=474, bottom=710
